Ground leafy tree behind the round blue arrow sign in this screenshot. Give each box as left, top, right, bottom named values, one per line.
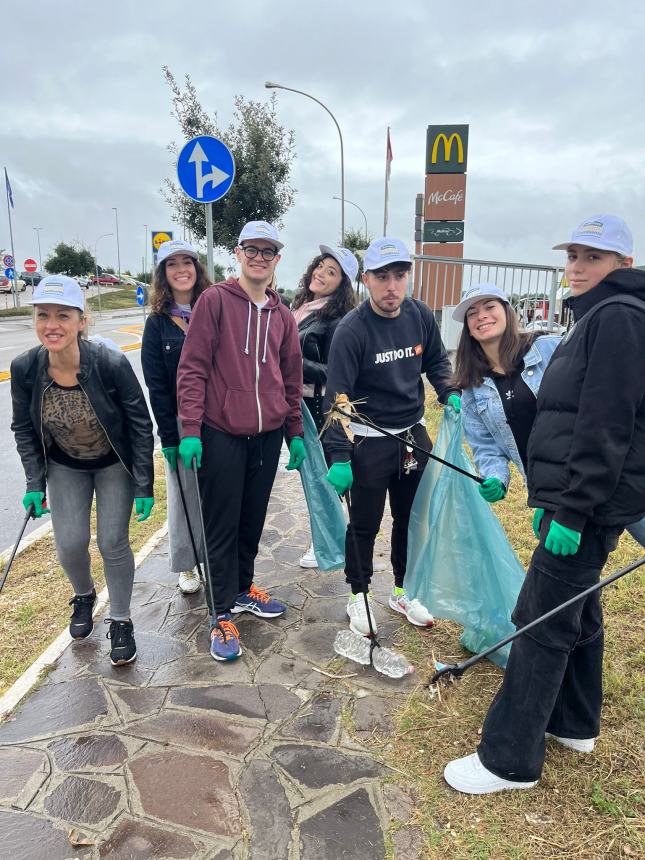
left=161, top=66, right=295, bottom=252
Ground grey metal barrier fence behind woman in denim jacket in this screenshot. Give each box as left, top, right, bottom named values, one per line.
left=412, top=255, right=562, bottom=348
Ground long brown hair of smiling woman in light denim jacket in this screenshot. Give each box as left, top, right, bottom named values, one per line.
left=451, top=300, right=540, bottom=388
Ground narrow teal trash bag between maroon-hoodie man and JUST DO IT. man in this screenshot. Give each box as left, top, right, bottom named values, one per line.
left=300, top=402, right=347, bottom=570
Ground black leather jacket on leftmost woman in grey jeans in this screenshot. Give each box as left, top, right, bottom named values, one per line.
left=11, top=340, right=154, bottom=498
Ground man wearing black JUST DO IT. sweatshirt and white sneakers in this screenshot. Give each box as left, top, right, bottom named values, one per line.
left=323, top=238, right=460, bottom=636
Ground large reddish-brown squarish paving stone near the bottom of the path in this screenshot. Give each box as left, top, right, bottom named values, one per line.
left=129, top=750, right=241, bottom=836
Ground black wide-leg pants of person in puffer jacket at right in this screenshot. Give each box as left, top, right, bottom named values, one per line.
left=478, top=511, right=622, bottom=782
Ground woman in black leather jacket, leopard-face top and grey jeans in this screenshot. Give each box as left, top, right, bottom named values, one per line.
left=11, top=275, right=154, bottom=666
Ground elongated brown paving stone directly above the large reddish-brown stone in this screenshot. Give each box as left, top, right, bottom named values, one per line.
left=127, top=710, right=261, bottom=756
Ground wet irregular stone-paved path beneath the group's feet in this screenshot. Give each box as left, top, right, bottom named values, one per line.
left=0, top=470, right=421, bottom=860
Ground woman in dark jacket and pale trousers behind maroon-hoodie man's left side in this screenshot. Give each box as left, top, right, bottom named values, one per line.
left=141, top=239, right=210, bottom=594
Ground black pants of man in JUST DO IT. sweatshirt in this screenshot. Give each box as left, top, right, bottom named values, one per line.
left=345, top=424, right=432, bottom=594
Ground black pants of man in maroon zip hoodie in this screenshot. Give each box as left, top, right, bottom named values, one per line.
left=198, top=424, right=282, bottom=612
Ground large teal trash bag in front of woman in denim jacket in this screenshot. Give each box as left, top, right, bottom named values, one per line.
left=404, top=410, right=524, bottom=667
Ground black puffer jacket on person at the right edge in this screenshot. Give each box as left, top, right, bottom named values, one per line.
left=527, top=269, right=645, bottom=531
